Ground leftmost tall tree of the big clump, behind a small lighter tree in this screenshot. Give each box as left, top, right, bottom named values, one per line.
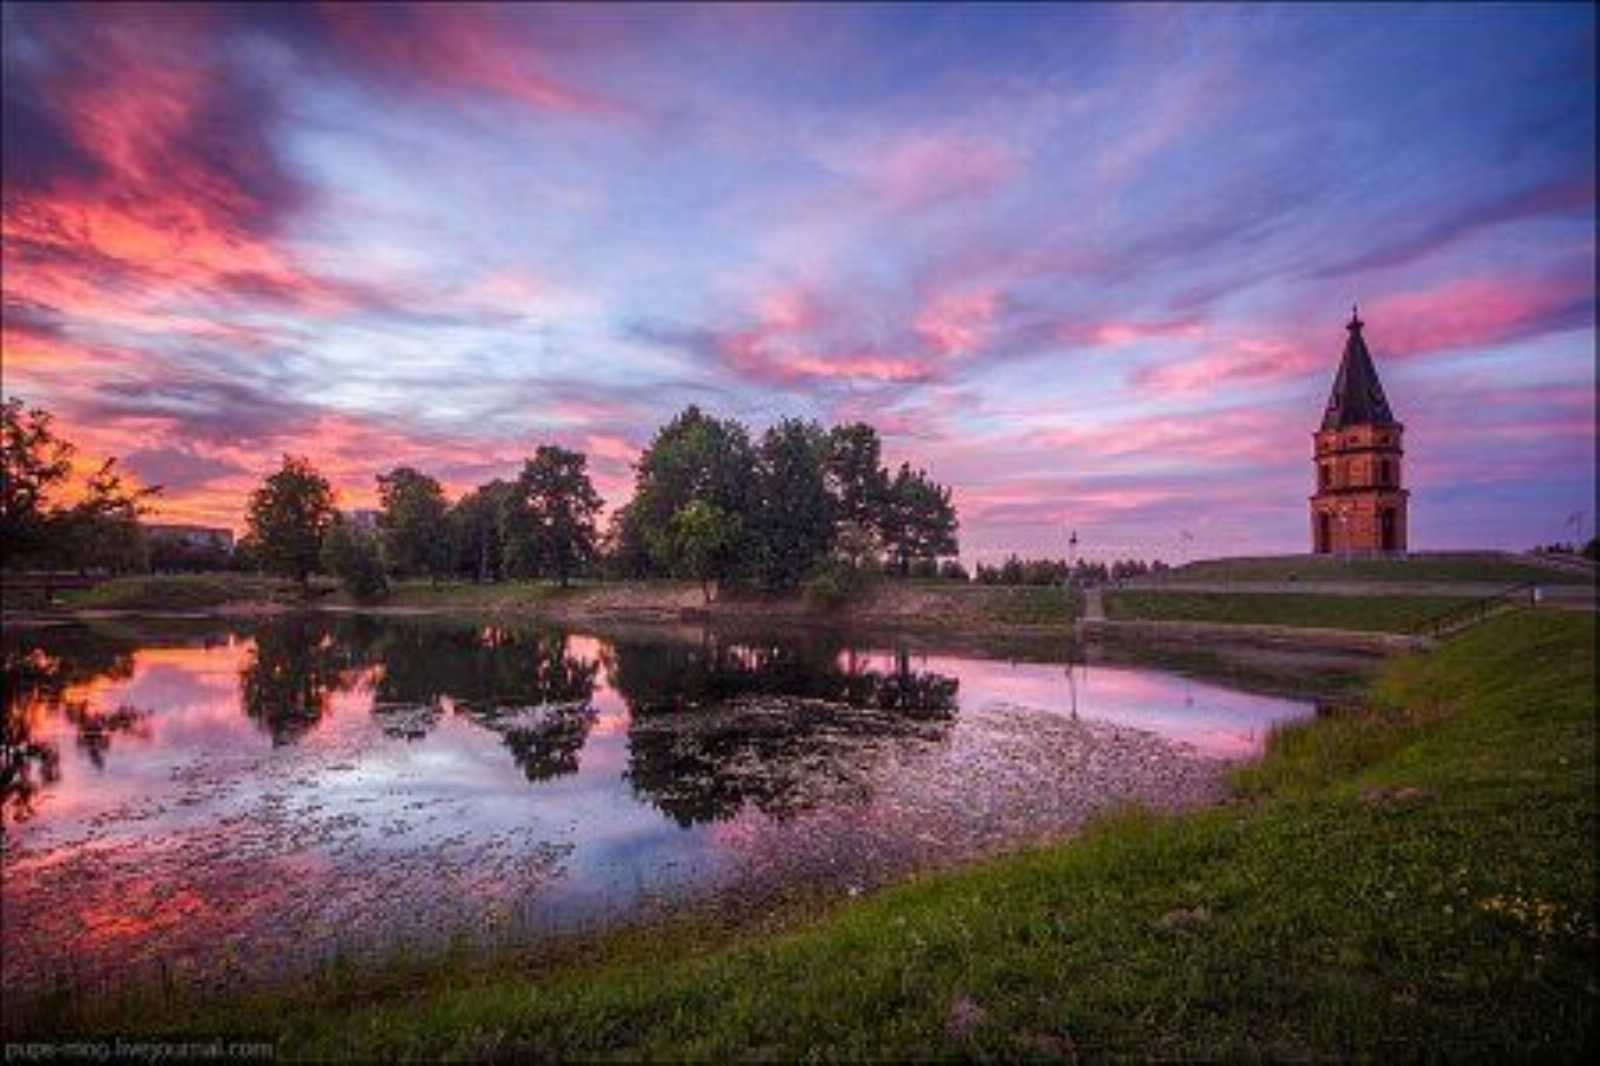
left=629, top=405, right=755, bottom=576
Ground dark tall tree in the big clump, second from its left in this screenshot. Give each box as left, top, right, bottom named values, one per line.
left=750, top=418, right=835, bottom=589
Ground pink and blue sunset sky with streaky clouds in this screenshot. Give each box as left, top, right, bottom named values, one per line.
left=0, top=3, right=1595, bottom=563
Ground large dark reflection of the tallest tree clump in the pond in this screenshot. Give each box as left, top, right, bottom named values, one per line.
left=608, top=634, right=958, bottom=826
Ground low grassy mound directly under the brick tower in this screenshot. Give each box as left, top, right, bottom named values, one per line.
left=1163, top=552, right=1594, bottom=586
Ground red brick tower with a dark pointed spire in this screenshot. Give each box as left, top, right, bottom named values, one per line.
left=1310, top=307, right=1410, bottom=554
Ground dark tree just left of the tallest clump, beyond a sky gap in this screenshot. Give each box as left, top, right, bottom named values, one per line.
left=501, top=445, right=603, bottom=589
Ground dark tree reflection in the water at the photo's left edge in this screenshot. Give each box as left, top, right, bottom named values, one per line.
left=0, top=627, right=144, bottom=826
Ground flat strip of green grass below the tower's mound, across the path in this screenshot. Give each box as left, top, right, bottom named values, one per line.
left=1106, top=589, right=1469, bottom=632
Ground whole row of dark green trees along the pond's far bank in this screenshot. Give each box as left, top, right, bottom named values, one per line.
left=240, top=407, right=965, bottom=600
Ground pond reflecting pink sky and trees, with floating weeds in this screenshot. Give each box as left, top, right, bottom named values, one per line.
left=0, top=613, right=1315, bottom=992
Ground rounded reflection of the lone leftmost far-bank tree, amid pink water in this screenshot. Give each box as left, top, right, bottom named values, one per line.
left=238, top=615, right=362, bottom=744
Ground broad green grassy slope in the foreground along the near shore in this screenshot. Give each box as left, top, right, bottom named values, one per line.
left=18, top=611, right=1597, bottom=1061
